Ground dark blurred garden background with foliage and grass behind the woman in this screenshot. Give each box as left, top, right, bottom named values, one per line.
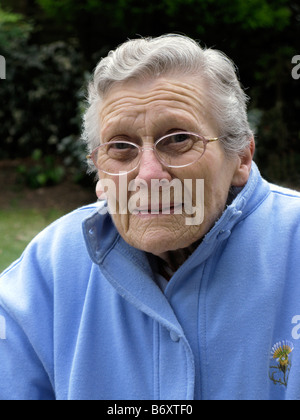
left=0, top=0, right=300, bottom=272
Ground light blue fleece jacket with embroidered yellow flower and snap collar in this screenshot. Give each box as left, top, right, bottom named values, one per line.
left=0, top=164, right=300, bottom=400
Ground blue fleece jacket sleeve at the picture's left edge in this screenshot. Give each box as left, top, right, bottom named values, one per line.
left=0, top=244, right=55, bottom=400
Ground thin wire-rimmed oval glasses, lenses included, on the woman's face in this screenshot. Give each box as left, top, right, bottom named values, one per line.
left=87, top=131, right=219, bottom=175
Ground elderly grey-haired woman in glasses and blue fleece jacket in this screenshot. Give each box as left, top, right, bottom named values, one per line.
left=0, top=35, right=300, bottom=400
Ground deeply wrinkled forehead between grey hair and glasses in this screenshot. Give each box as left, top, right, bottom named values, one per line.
left=100, top=77, right=213, bottom=136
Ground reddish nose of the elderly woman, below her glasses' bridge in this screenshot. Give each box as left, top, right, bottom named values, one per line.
left=136, top=147, right=172, bottom=186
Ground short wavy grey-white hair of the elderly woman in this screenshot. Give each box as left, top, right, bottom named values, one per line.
left=83, top=34, right=253, bottom=171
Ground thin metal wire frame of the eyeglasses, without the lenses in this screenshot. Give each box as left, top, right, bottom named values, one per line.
left=86, top=131, right=221, bottom=176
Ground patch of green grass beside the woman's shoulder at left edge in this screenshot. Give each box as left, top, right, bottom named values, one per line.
left=0, top=208, right=64, bottom=273
